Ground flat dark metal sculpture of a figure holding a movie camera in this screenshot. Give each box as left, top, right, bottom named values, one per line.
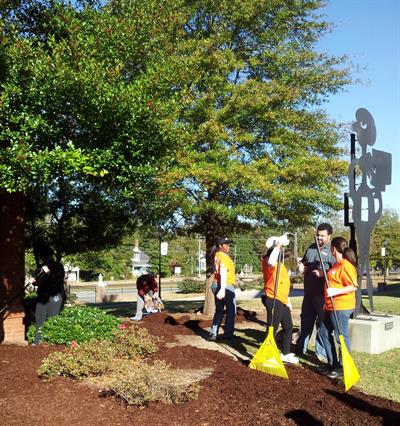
left=345, top=108, right=392, bottom=314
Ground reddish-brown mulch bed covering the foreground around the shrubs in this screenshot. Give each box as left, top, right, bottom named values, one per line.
left=0, top=313, right=400, bottom=426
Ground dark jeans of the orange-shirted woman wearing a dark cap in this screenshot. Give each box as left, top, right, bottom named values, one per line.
left=211, top=283, right=236, bottom=337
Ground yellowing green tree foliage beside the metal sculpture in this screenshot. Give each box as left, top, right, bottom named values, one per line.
left=152, top=0, right=351, bottom=312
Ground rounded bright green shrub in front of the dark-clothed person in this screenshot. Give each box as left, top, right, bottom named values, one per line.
left=27, top=306, right=119, bottom=345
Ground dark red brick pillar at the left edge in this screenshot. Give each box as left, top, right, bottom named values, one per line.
left=0, top=190, right=26, bottom=344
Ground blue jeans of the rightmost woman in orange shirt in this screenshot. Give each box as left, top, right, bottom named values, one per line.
left=320, top=309, right=354, bottom=368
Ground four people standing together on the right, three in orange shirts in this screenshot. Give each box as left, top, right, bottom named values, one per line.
left=209, top=223, right=358, bottom=378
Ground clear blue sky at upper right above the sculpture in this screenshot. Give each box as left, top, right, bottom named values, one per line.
left=319, top=0, right=400, bottom=213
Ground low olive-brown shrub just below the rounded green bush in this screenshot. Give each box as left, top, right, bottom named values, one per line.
left=38, top=325, right=158, bottom=380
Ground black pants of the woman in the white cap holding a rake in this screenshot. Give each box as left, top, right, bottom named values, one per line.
left=261, top=296, right=293, bottom=355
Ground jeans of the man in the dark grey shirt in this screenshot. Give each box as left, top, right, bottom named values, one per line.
left=296, top=294, right=326, bottom=357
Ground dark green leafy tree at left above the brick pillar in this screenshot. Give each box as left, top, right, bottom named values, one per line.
left=0, top=0, right=184, bottom=257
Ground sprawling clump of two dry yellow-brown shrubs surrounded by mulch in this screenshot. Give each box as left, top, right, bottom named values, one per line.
left=38, top=325, right=210, bottom=406
